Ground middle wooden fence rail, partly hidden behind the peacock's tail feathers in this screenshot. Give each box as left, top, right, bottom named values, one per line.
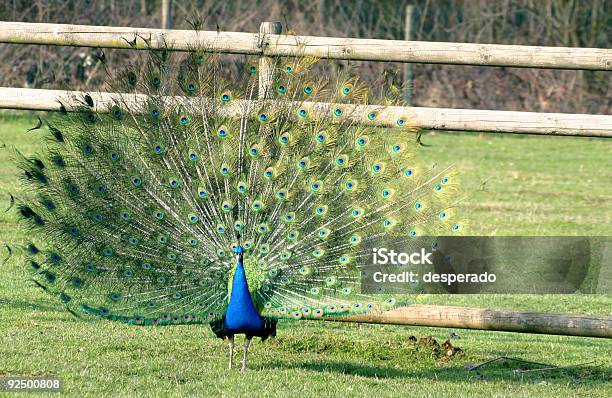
left=0, top=87, right=612, bottom=137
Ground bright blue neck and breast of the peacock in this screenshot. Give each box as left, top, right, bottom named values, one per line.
left=224, top=250, right=264, bottom=334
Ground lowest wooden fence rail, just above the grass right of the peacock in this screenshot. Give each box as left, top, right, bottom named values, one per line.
left=324, top=305, right=612, bottom=338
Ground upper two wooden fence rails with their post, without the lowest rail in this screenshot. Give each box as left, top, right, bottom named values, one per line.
left=0, top=22, right=612, bottom=137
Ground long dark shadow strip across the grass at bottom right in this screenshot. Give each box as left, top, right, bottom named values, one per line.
left=262, top=360, right=612, bottom=385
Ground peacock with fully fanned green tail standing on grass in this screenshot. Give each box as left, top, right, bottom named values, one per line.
left=15, top=40, right=462, bottom=370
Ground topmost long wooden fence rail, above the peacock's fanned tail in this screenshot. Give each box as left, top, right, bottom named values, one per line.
left=0, top=22, right=612, bottom=71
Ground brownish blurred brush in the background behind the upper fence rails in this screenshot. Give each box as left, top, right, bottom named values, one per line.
left=0, top=0, right=612, bottom=114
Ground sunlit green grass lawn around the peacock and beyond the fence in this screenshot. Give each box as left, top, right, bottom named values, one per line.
left=0, top=115, right=612, bottom=398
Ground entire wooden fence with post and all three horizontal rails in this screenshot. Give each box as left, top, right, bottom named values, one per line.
left=0, top=18, right=612, bottom=338
